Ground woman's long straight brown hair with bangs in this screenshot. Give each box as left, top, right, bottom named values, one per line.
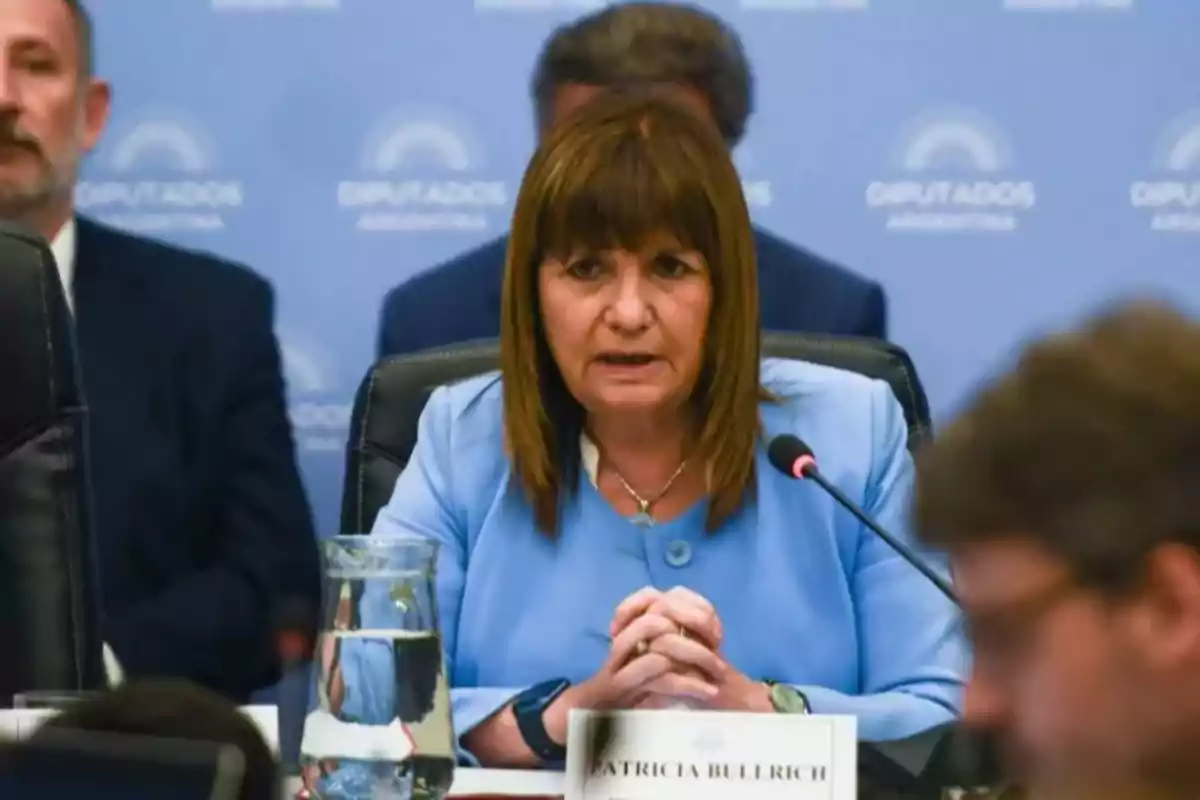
left=500, top=90, right=763, bottom=536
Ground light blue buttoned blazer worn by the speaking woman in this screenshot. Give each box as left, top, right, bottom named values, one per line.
left=343, top=360, right=967, bottom=762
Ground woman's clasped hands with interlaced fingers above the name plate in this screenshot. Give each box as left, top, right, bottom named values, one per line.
left=578, top=587, right=773, bottom=711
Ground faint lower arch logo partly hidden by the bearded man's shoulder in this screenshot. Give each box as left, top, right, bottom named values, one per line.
left=278, top=330, right=352, bottom=453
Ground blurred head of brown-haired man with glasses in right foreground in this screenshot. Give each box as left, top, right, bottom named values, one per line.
left=916, top=302, right=1200, bottom=798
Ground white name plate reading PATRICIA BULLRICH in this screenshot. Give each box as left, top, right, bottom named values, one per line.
left=565, top=711, right=858, bottom=800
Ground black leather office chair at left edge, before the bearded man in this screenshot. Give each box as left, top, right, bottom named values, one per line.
left=0, top=223, right=104, bottom=706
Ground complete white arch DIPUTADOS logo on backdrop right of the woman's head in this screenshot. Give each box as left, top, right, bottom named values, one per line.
left=865, top=108, right=1037, bottom=234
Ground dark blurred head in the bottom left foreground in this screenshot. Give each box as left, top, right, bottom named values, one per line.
left=34, top=680, right=281, bottom=800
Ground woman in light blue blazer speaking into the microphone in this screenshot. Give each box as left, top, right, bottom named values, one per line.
left=344, top=94, right=965, bottom=766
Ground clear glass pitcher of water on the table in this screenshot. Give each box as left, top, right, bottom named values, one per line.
left=301, top=537, right=455, bottom=800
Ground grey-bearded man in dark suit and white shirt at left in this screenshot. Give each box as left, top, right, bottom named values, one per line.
left=0, top=0, right=319, bottom=700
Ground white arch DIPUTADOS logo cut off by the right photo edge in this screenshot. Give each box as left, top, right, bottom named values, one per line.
left=1129, top=108, right=1200, bottom=234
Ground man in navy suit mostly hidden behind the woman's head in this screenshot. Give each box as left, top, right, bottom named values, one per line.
left=378, top=2, right=887, bottom=356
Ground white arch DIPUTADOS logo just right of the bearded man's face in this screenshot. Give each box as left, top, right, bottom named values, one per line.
left=76, top=110, right=245, bottom=234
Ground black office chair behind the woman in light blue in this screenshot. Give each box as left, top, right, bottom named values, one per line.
left=342, top=333, right=932, bottom=533
